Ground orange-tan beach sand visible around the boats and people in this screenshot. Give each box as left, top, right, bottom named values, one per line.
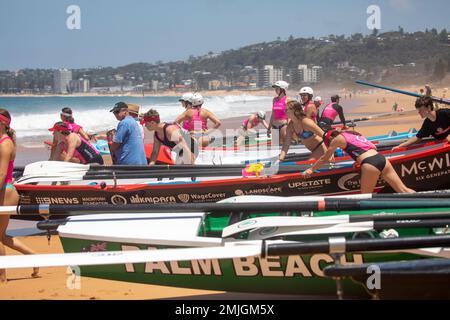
left=0, top=85, right=446, bottom=300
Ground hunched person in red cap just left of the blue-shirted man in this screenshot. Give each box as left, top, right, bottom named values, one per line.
left=48, top=122, right=103, bottom=164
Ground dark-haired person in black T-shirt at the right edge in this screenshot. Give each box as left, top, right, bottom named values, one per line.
left=393, top=97, right=450, bottom=150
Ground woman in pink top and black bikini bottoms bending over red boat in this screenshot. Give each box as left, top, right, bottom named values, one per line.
left=304, top=130, right=415, bottom=193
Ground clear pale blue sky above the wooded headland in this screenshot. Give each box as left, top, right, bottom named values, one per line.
left=0, top=0, right=450, bottom=70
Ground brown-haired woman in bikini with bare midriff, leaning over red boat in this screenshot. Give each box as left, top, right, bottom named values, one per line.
left=279, top=100, right=327, bottom=161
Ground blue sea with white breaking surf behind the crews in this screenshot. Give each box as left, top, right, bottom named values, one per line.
left=0, top=95, right=272, bottom=147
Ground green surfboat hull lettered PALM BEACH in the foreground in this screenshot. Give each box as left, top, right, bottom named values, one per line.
left=60, top=208, right=450, bottom=298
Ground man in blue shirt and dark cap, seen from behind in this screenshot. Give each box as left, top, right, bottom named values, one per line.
left=109, top=102, right=147, bottom=165
